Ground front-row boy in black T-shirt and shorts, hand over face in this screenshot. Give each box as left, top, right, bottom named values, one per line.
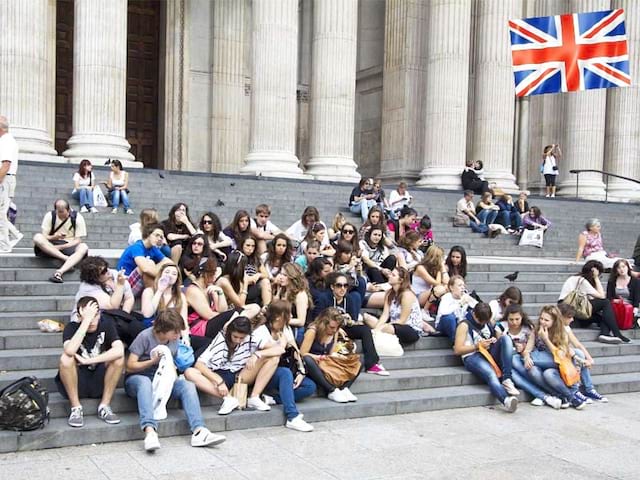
left=55, top=297, right=124, bottom=427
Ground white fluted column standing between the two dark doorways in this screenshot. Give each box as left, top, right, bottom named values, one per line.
left=63, top=0, right=135, bottom=166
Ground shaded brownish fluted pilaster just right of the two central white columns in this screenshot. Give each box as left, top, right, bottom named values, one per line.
left=380, top=0, right=428, bottom=181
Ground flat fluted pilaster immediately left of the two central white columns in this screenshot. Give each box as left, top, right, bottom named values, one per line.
left=211, top=0, right=246, bottom=173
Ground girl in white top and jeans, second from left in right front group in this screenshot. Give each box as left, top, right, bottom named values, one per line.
left=496, top=303, right=562, bottom=410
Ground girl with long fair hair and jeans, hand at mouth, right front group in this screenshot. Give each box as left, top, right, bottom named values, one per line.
left=522, top=305, right=587, bottom=410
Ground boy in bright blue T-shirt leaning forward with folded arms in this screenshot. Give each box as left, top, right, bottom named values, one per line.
left=118, top=223, right=171, bottom=297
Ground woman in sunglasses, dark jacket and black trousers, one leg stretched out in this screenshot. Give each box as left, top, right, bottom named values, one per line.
left=312, top=272, right=389, bottom=376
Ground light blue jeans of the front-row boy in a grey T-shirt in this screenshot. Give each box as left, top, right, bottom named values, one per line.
left=124, top=375, right=205, bottom=432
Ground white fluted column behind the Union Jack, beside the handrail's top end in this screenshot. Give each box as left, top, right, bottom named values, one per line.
left=558, top=0, right=610, bottom=200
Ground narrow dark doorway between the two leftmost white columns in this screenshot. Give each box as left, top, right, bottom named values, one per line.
left=55, top=0, right=73, bottom=155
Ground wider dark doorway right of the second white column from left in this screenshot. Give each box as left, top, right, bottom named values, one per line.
left=126, top=0, right=162, bottom=168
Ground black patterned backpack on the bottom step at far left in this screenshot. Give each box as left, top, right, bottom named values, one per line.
left=0, top=377, right=49, bottom=431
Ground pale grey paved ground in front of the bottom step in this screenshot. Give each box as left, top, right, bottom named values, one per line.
left=0, top=393, right=640, bottom=480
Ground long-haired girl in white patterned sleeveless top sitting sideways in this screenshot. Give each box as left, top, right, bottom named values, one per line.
left=365, top=267, right=435, bottom=345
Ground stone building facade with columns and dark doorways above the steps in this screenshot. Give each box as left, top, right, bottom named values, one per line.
left=0, top=0, right=640, bottom=199
